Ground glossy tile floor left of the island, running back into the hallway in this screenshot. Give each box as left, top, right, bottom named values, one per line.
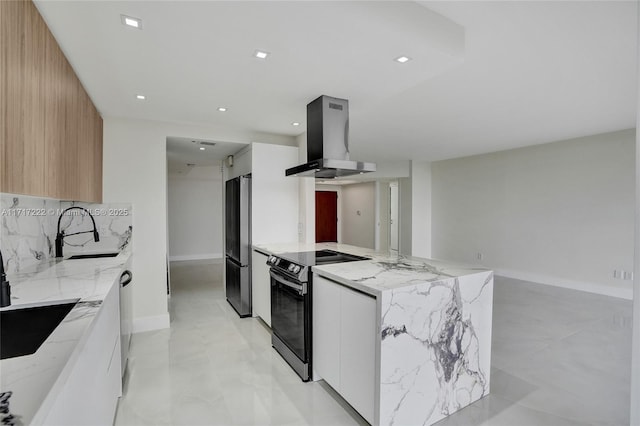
left=115, top=261, right=366, bottom=425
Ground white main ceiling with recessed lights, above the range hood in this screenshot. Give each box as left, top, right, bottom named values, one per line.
left=36, top=1, right=637, bottom=161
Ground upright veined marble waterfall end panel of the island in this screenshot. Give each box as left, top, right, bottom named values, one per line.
left=380, top=271, right=493, bottom=425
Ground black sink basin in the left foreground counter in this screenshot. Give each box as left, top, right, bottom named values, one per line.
left=0, top=300, right=77, bottom=359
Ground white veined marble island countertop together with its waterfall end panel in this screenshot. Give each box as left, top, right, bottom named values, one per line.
left=254, top=243, right=493, bottom=425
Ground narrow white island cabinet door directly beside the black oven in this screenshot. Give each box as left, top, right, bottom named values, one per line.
left=312, top=275, right=341, bottom=391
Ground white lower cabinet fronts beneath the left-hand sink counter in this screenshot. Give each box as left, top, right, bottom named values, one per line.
left=44, top=282, right=122, bottom=425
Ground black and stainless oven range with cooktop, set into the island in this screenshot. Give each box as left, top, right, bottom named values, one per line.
left=267, top=250, right=367, bottom=382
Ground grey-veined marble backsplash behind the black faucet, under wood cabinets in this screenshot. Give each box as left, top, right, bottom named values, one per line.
left=0, top=193, right=133, bottom=278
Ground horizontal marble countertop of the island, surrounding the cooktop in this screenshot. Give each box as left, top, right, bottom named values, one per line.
left=253, top=243, right=489, bottom=296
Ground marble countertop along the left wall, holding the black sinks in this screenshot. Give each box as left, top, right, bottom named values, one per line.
left=0, top=250, right=131, bottom=424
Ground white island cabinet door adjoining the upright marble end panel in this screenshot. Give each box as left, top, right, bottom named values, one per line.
left=340, top=287, right=376, bottom=423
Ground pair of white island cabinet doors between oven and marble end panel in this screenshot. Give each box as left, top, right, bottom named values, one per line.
left=313, top=274, right=376, bottom=423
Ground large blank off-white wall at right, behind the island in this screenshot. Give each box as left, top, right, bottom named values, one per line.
left=432, top=130, right=635, bottom=298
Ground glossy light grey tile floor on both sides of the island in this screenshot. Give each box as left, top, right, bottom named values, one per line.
left=115, top=261, right=631, bottom=426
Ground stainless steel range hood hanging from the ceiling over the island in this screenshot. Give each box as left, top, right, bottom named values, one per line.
left=285, top=96, right=376, bottom=179
